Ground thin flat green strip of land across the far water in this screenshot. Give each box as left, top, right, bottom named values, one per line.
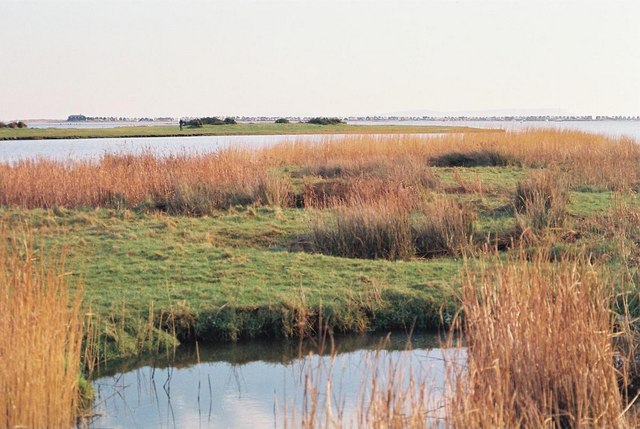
left=0, top=123, right=500, bottom=140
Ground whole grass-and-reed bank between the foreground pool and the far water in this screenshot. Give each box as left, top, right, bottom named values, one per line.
left=0, top=131, right=640, bottom=364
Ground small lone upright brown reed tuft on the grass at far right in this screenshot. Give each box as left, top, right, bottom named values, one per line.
left=513, top=169, right=570, bottom=233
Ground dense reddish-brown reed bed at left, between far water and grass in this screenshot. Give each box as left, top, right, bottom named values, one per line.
left=0, top=150, right=282, bottom=214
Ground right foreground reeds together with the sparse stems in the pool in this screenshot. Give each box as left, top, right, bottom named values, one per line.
left=293, top=251, right=638, bottom=429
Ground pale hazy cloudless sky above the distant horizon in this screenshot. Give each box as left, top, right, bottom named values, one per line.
left=0, top=0, right=640, bottom=120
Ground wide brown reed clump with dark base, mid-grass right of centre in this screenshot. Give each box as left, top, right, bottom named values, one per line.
left=311, top=191, right=475, bottom=259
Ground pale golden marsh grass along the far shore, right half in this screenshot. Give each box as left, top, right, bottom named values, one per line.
left=268, top=129, right=640, bottom=190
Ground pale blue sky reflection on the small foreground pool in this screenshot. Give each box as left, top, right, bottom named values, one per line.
left=91, top=335, right=462, bottom=429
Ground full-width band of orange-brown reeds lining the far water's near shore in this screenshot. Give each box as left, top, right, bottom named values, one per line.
left=0, top=130, right=640, bottom=214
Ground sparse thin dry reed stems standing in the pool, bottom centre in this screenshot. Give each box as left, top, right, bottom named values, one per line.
left=284, top=337, right=442, bottom=429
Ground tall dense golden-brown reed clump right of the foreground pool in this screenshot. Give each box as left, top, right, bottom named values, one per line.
left=447, top=249, right=631, bottom=428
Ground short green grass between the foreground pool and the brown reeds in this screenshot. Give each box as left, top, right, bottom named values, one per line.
left=2, top=208, right=461, bottom=354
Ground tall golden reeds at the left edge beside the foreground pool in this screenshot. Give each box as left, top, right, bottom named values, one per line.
left=0, top=230, right=82, bottom=428
